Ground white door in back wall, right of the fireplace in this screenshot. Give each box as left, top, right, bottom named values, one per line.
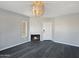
left=42, top=22, right=53, bottom=40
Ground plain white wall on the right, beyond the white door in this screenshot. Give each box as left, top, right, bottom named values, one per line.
left=54, top=14, right=79, bottom=47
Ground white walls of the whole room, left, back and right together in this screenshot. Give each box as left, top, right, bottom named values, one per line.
left=0, top=9, right=79, bottom=50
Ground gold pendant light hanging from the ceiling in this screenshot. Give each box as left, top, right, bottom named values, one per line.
left=32, top=1, right=44, bottom=16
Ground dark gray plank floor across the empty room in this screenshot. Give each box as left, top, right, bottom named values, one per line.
left=0, top=40, right=79, bottom=58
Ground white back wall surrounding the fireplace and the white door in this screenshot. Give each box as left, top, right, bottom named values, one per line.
left=29, top=17, right=54, bottom=41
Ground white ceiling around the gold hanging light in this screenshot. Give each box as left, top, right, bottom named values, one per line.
left=0, top=1, right=79, bottom=17
